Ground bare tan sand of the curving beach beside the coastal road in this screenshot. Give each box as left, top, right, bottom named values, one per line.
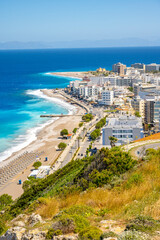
left=0, top=90, right=84, bottom=199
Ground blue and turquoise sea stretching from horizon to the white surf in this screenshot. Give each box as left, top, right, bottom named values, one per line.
left=0, top=47, right=160, bottom=160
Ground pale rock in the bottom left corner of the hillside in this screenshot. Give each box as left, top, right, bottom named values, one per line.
left=0, top=227, right=26, bottom=240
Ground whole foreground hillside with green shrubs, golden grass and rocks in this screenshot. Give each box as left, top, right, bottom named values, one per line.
left=0, top=147, right=160, bottom=240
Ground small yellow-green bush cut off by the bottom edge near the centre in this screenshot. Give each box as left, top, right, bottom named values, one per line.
left=79, top=227, right=102, bottom=240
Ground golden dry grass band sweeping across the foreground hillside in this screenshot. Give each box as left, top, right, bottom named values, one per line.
left=37, top=157, right=160, bottom=219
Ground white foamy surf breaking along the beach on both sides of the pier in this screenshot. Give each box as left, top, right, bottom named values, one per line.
left=0, top=89, right=76, bottom=162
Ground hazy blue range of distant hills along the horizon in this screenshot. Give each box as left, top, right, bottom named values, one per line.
left=0, top=38, right=160, bottom=50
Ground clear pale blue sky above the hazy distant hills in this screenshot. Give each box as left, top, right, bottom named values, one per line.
left=0, top=0, right=160, bottom=42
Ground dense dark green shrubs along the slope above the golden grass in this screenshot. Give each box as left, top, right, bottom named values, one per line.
left=7, top=147, right=136, bottom=216
